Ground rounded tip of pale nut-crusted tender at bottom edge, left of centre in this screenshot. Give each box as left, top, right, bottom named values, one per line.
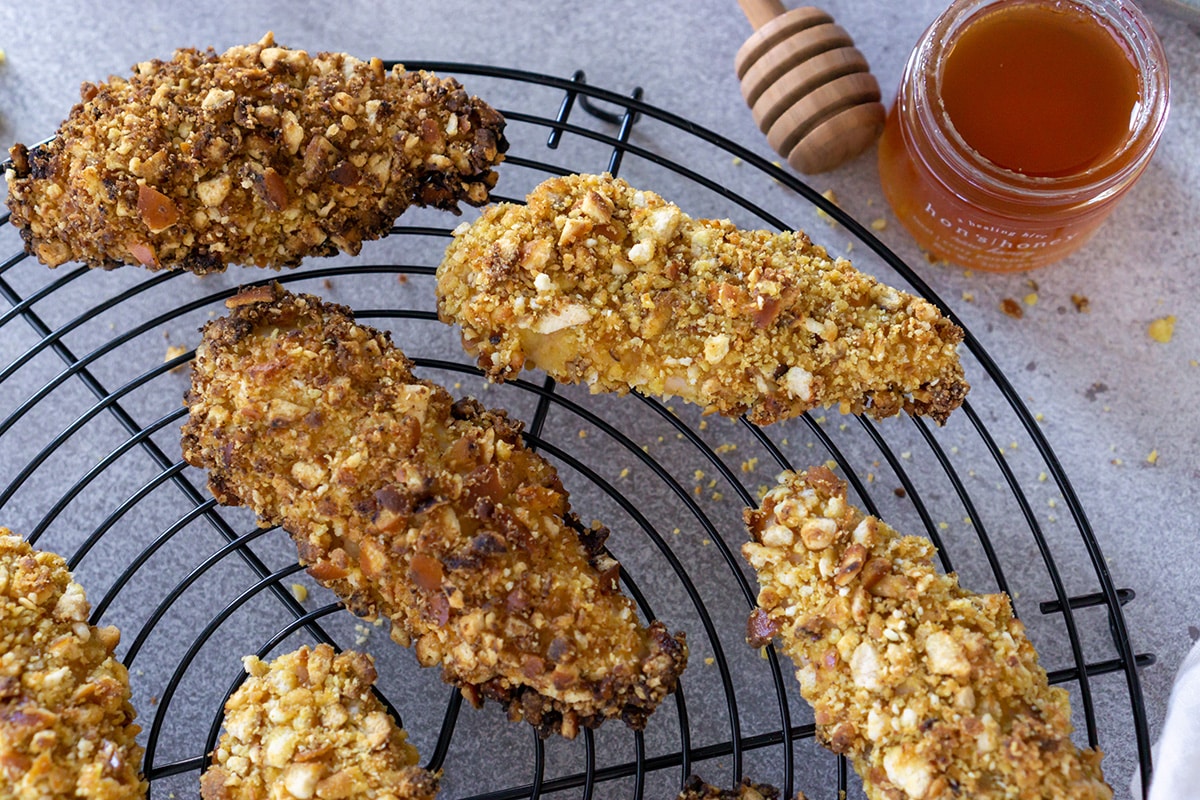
left=200, top=644, right=438, bottom=800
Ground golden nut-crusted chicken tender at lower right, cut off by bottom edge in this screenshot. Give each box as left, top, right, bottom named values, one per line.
left=742, top=468, right=1112, bottom=800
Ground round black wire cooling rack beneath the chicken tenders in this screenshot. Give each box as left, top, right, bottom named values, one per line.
left=0, top=64, right=1153, bottom=800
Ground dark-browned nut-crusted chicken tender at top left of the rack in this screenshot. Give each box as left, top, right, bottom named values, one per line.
left=7, top=34, right=506, bottom=273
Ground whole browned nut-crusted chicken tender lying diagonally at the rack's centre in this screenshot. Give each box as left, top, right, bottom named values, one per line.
left=182, top=285, right=686, bottom=738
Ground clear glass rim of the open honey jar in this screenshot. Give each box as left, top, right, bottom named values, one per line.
left=898, top=0, right=1170, bottom=205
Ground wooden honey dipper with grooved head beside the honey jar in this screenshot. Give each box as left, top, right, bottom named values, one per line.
left=733, top=0, right=886, bottom=174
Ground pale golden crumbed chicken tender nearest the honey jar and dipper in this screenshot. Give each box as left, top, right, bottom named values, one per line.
left=438, top=175, right=968, bottom=425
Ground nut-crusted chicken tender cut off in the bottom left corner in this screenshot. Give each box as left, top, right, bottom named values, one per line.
left=0, top=528, right=148, bottom=800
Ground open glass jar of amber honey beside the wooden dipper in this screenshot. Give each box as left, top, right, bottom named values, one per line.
left=878, top=0, right=1169, bottom=271
